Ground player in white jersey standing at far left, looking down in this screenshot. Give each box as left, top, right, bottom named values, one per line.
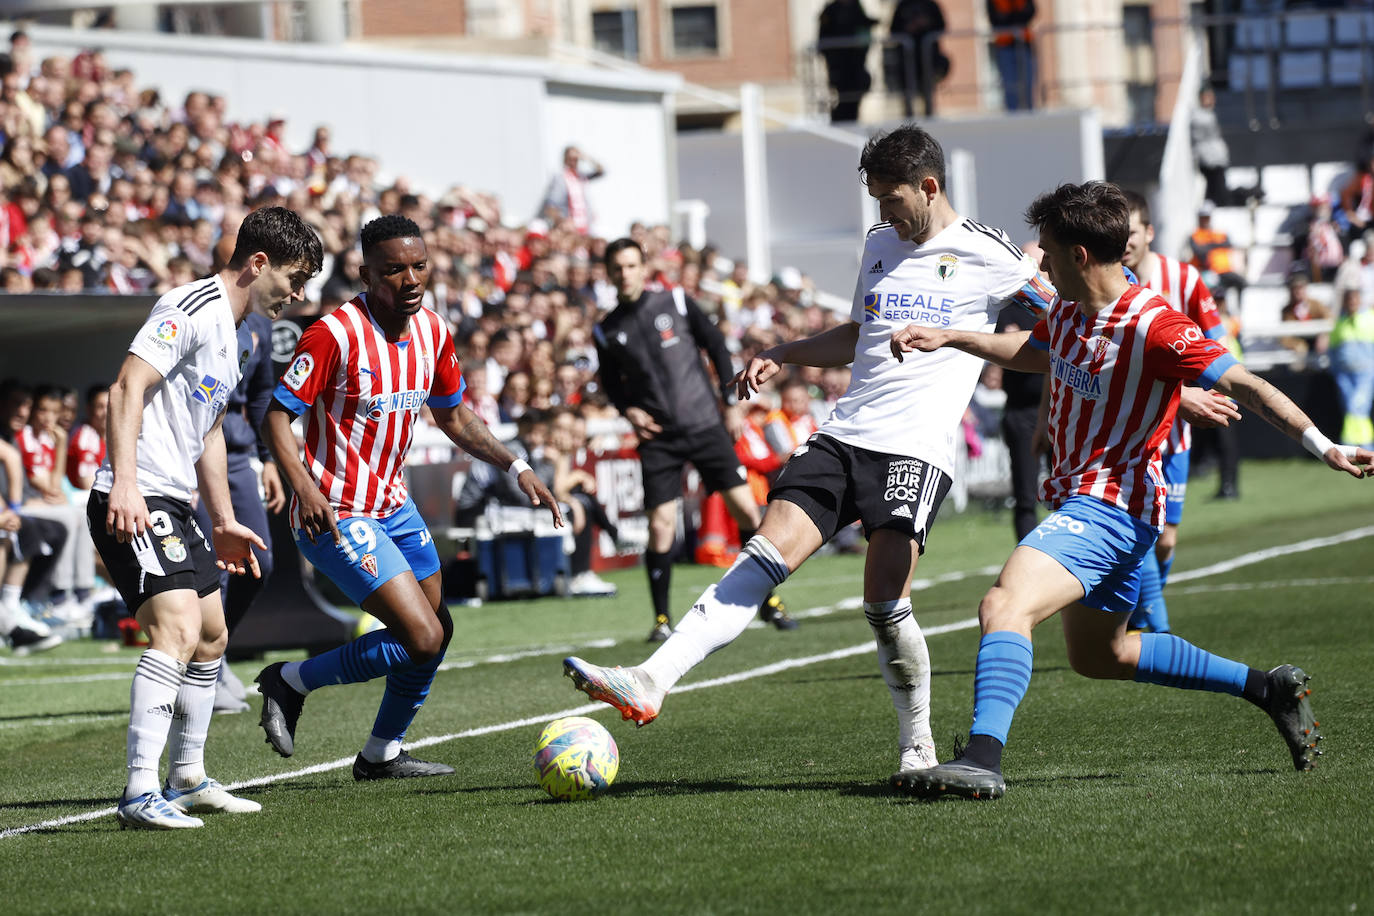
left=87, top=207, right=322, bottom=829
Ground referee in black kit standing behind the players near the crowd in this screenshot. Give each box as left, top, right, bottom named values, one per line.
left=595, top=239, right=797, bottom=643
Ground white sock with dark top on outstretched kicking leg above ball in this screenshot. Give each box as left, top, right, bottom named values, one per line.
left=639, top=534, right=791, bottom=694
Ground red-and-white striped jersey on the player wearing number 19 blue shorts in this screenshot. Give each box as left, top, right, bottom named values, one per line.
left=273, top=295, right=464, bottom=527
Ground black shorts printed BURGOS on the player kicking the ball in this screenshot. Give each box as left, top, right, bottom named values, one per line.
left=768, top=433, right=951, bottom=553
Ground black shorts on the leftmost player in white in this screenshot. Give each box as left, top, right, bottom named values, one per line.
left=87, top=490, right=220, bottom=612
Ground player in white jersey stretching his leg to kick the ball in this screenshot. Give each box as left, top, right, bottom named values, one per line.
left=563, top=125, right=1052, bottom=770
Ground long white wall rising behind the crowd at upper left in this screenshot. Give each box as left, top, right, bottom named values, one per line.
left=29, top=26, right=680, bottom=236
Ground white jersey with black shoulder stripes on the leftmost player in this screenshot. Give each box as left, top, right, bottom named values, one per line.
left=95, top=276, right=249, bottom=501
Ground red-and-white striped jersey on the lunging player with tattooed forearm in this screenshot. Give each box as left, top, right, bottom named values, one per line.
left=1031, top=286, right=1235, bottom=527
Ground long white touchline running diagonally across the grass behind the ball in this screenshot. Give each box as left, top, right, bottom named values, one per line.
left=0, top=526, right=1374, bottom=839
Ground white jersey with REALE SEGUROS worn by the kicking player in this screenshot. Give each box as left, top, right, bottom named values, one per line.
left=820, top=218, right=1052, bottom=475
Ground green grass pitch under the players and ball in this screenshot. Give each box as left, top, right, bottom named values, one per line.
left=0, top=460, right=1374, bottom=916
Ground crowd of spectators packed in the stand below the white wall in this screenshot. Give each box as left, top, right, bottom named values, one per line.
left=0, top=32, right=848, bottom=648
